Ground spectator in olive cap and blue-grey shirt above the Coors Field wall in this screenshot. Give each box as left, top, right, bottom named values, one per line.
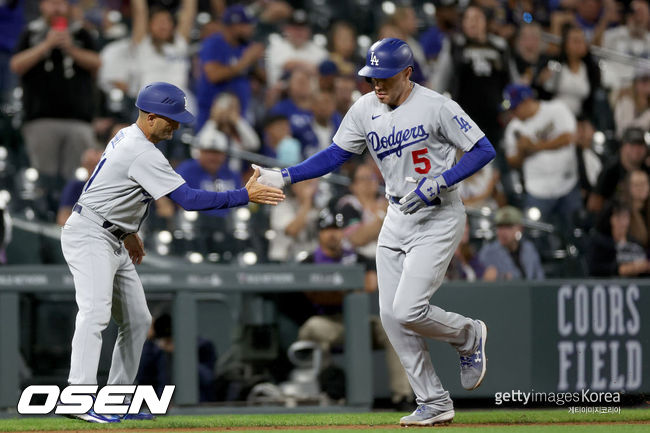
left=478, top=206, right=544, bottom=280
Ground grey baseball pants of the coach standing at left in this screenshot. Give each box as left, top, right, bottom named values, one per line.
left=61, top=212, right=151, bottom=385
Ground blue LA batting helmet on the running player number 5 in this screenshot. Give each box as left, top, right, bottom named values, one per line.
left=359, top=38, right=414, bottom=78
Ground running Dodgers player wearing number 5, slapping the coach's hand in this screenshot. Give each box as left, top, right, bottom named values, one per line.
left=252, top=38, right=495, bottom=426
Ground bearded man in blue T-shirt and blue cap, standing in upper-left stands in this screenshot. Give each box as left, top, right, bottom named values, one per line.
left=196, top=4, right=264, bottom=131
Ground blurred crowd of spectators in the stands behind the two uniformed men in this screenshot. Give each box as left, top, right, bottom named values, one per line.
left=0, top=0, right=650, bottom=408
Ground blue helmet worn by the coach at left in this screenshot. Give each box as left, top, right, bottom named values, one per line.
left=135, top=81, right=194, bottom=123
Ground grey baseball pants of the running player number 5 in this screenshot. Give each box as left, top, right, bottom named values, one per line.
left=377, top=191, right=481, bottom=411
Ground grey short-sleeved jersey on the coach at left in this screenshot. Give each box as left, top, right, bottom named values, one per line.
left=79, top=123, right=185, bottom=232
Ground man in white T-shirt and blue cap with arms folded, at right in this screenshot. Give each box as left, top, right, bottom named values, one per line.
left=504, top=84, right=582, bottom=233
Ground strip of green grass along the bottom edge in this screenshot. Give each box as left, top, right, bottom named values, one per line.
left=0, top=409, right=650, bottom=433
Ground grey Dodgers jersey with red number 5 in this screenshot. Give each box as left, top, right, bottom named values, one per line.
left=333, top=84, right=485, bottom=197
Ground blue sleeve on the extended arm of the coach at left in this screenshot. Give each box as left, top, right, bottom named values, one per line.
left=167, top=183, right=248, bottom=211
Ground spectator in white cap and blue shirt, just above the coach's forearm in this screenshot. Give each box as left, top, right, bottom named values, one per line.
left=176, top=130, right=243, bottom=216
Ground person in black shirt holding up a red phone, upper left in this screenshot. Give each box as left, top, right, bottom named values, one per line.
left=10, top=0, right=101, bottom=214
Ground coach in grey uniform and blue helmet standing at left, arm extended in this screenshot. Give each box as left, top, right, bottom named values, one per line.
left=61, top=82, right=284, bottom=423
